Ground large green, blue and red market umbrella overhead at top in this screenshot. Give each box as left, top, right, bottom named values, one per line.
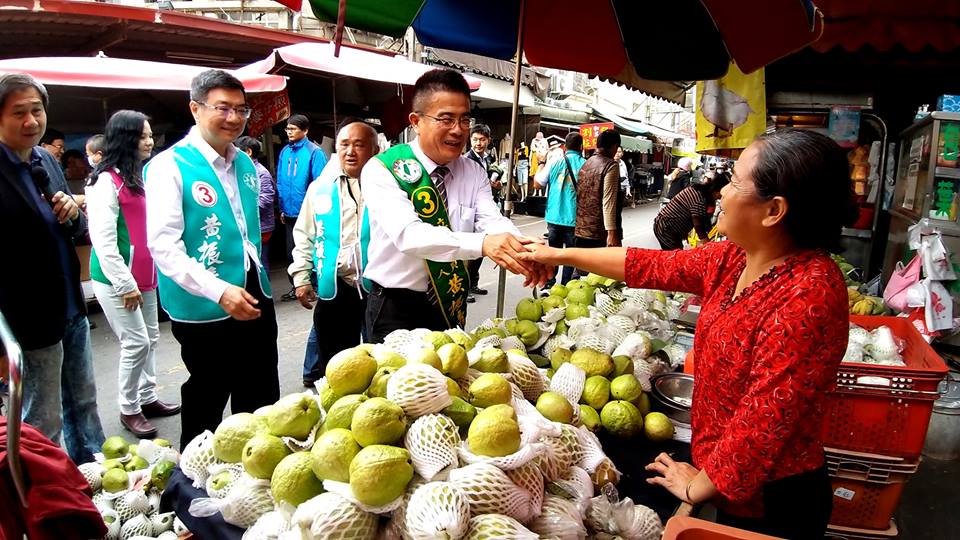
left=310, top=0, right=822, bottom=101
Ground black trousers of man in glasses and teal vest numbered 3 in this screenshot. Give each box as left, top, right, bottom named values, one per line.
left=171, top=268, right=280, bottom=449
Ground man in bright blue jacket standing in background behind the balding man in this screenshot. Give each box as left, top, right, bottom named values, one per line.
left=277, top=114, right=327, bottom=300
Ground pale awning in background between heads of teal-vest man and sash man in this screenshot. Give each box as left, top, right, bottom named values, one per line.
left=237, top=43, right=480, bottom=90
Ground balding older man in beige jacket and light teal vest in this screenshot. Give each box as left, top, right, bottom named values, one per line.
left=288, top=122, right=377, bottom=387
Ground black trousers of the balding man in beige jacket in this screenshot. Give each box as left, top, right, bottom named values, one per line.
left=303, top=278, right=367, bottom=381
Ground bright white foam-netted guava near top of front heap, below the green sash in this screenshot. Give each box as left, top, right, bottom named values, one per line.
left=387, top=363, right=453, bottom=418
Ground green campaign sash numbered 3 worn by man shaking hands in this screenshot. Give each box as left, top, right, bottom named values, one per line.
left=376, top=144, right=470, bottom=328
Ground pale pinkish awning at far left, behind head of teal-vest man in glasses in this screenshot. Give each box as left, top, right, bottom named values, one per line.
left=0, top=56, right=287, bottom=93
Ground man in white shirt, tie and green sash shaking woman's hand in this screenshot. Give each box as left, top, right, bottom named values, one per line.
left=362, top=69, right=550, bottom=343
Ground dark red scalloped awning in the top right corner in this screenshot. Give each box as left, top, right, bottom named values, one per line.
left=811, top=0, right=960, bottom=52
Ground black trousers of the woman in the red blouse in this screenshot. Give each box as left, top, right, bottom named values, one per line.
left=717, top=465, right=833, bottom=540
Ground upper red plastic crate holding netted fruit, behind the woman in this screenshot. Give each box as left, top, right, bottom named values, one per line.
left=821, top=315, right=947, bottom=459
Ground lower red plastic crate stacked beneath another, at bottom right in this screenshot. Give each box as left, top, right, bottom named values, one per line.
left=826, top=448, right=920, bottom=532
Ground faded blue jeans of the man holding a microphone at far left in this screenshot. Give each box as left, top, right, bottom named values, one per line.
left=23, top=315, right=104, bottom=464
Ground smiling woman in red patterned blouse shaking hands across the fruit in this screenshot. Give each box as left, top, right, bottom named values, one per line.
left=521, top=129, right=857, bottom=538
